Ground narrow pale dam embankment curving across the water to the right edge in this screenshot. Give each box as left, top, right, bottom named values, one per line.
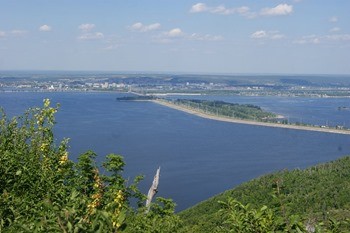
left=151, top=100, right=350, bottom=135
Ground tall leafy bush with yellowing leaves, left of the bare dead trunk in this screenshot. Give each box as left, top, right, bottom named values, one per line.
left=0, top=100, right=180, bottom=232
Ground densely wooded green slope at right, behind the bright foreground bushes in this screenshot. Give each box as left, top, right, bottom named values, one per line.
left=179, top=156, right=350, bottom=232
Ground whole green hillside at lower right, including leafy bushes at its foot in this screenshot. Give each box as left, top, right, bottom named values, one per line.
left=179, top=157, right=350, bottom=232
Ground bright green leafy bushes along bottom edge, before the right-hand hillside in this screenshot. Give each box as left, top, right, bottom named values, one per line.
left=215, top=198, right=350, bottom=233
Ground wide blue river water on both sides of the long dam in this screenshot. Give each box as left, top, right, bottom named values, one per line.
left=0, top=92, right=350, bottom=211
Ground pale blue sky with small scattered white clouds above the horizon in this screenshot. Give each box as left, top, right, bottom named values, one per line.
left=0, top=0, right=350, bottom=74
